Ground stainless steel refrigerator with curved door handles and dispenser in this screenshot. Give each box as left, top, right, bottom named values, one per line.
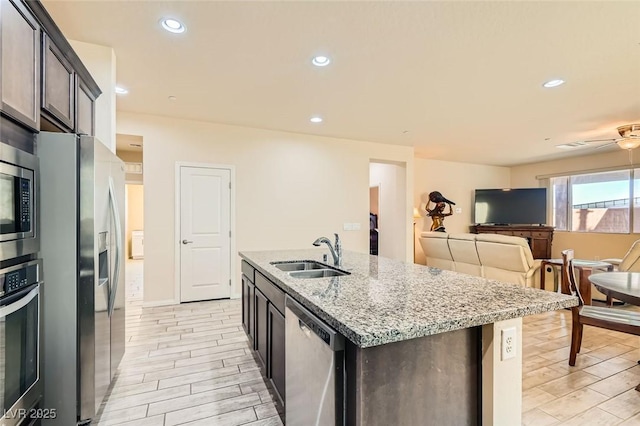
left=37, top=132, right=125, bottom=426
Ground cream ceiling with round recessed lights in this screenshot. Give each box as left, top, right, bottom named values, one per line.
left=43, top=0, right=640, bottom=166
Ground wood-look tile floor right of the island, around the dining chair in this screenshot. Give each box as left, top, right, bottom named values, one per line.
left=522, top=306, right=640, bottom=426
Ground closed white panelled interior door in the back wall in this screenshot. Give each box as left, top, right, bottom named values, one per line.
left=178, top=166, right=231, bottom=302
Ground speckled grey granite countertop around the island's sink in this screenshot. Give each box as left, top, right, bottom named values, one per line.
left=239, top=248, right=578, bottom=348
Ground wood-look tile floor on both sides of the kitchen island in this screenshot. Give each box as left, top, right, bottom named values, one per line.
left=95, top=261, right=640, bottom=426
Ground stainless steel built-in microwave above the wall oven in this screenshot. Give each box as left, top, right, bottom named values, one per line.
left=0, top=143, right=40, bottom=261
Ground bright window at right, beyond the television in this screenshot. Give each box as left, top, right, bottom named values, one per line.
left=550, top=169, right=640, bottom=234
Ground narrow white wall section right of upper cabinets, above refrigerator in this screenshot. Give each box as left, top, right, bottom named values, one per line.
left=69, top=40, right=116, bottom=152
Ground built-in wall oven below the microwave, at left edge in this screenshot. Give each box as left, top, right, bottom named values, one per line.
left=0, top=260, right=42, bottom=426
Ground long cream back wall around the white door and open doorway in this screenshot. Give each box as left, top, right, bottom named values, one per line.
left=117, top=112, right=413, bottom=304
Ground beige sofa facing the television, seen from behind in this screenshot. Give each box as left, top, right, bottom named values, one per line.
left=420, top=232, right=540, bottom=287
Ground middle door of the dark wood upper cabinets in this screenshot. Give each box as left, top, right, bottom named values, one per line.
left=42, top=34, right=76, bottom=131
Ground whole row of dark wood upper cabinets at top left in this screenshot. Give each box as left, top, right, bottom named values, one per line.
left=0, top=0, right=102, bottom=152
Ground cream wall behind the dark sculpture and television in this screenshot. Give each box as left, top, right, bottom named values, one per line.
left=413, top=158, right=511, bottom=265
